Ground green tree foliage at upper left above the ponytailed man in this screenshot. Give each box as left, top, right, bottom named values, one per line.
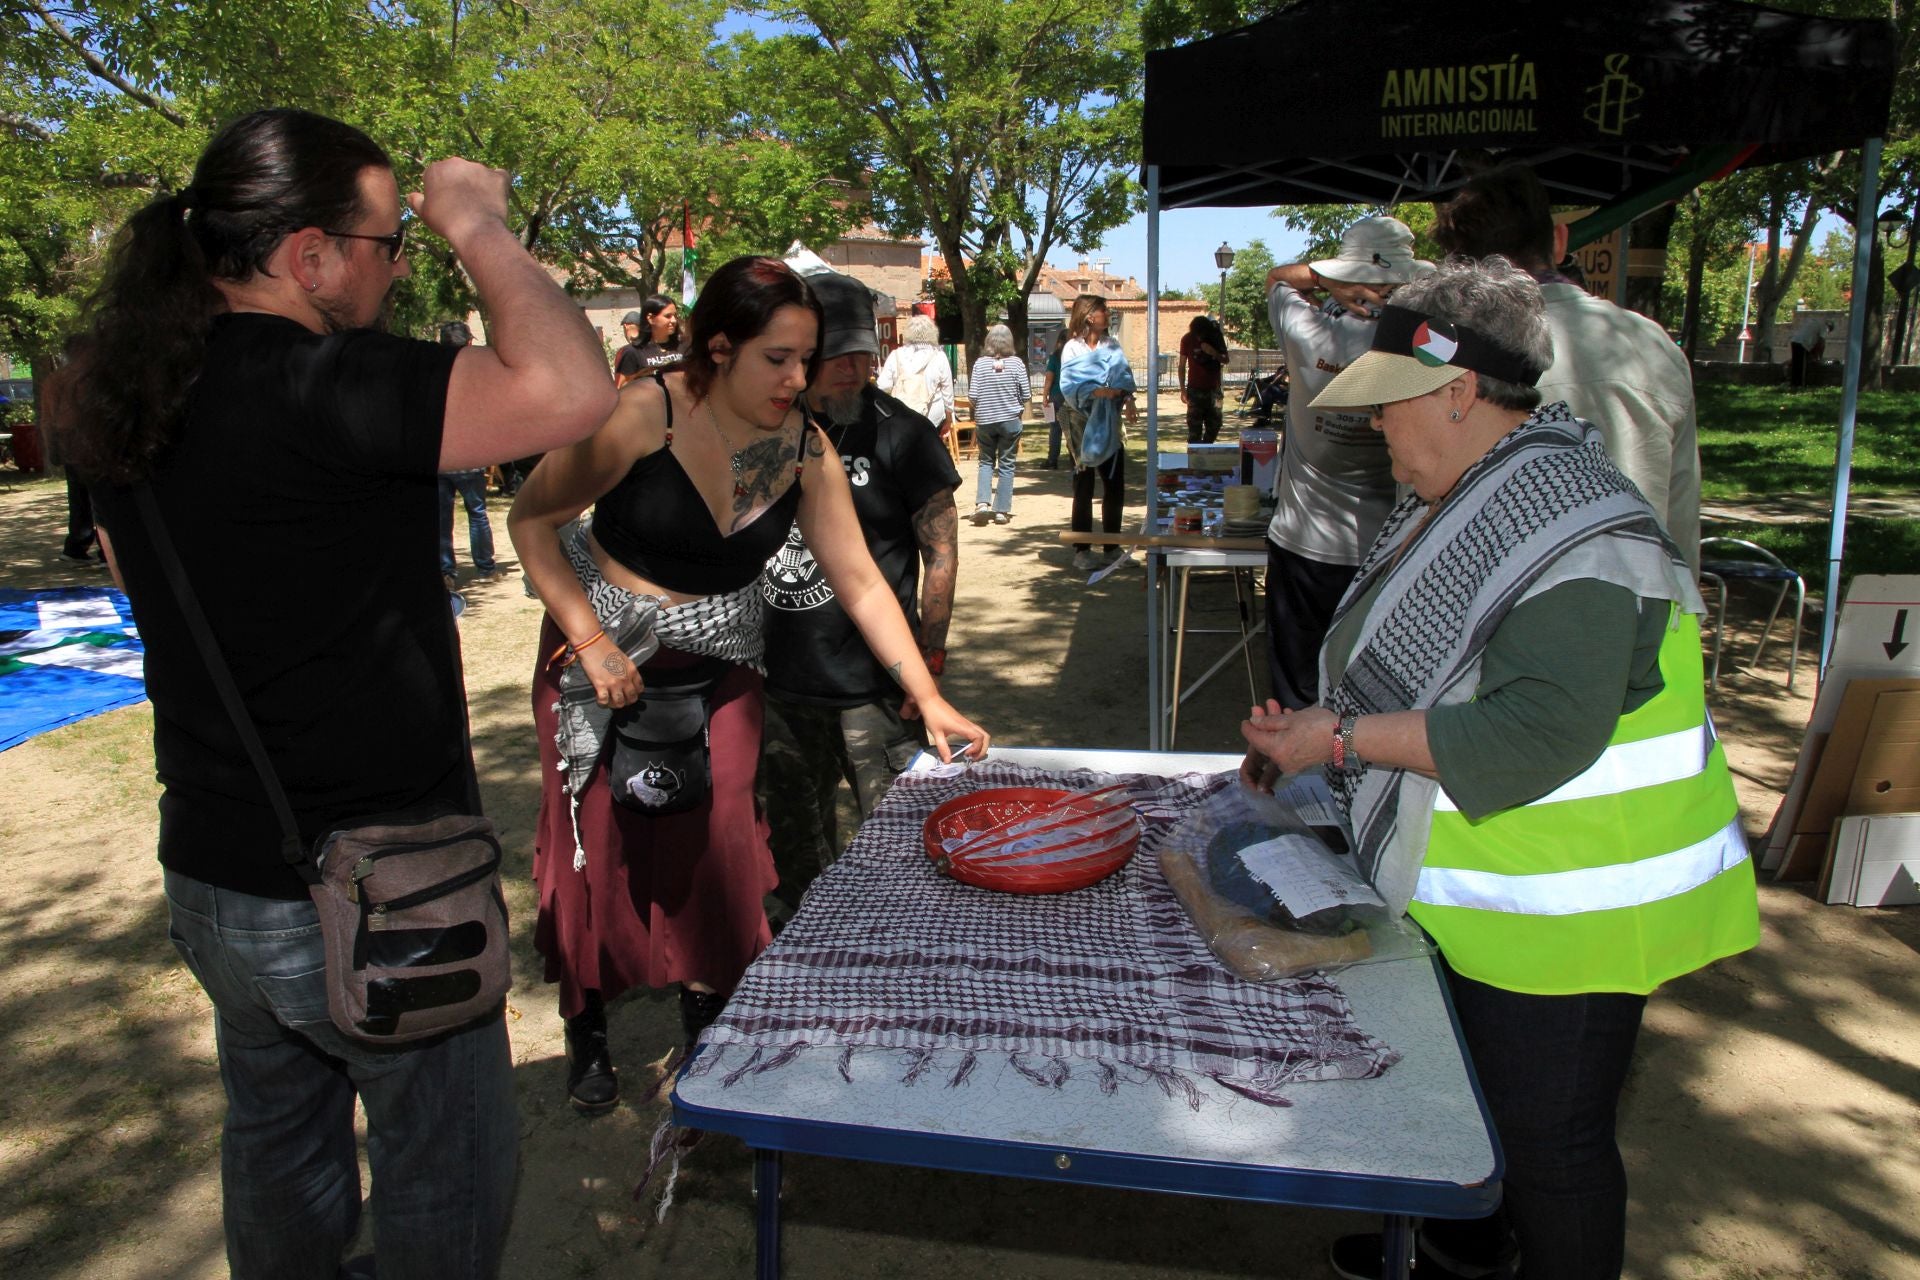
left=0, top=0, right=860, bottom=359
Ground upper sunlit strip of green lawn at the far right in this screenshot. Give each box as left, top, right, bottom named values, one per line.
left=1695, top=382, right=1920, bottom=498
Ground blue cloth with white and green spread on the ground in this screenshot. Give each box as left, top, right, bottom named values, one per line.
left=0, top=587, right=146, bottom=750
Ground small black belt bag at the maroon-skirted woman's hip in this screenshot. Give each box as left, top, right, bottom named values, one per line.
left=607, top=658, right=730, bottom=816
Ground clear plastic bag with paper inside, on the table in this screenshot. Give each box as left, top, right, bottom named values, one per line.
left=1160, top=783, right=1434, bottom=983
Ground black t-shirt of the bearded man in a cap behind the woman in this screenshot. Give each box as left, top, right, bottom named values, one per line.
left=760, top=386, right=960, bottom=706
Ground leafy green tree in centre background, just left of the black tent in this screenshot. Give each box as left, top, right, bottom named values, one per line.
left=751, top=0, right=1142, bottom=347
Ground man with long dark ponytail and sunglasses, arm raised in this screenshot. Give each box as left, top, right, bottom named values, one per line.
left=56, top=109, right=614, bottom=1280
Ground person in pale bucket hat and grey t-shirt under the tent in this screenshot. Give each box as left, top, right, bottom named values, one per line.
left=1265, top=217, right=1432, bottom=706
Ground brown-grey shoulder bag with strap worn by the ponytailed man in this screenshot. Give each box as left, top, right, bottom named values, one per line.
left=134, top=484, right=513, bottom=1046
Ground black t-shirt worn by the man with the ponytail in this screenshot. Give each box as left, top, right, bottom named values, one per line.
left=94, top=315, right=472, bottom=898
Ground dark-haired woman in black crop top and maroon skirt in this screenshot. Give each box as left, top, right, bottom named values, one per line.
left=507, top=257, right=989, bottom=1115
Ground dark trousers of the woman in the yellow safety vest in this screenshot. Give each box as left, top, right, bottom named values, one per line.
left=1421, top=955, right=1647, bottom=1280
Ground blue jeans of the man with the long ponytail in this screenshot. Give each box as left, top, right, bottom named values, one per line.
left=165, top=871, right=520, bottom=1280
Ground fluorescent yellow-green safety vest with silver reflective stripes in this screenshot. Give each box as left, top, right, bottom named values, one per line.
left=1407, top=606, right=1759, bottom=994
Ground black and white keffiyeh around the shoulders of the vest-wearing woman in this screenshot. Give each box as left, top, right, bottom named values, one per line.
left=1321, top=403, right=1705, bottom=912
